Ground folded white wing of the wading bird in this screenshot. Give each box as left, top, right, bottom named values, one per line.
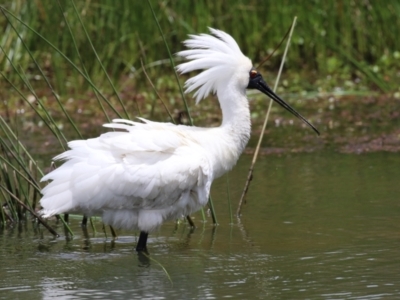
left=41, top=120, right=212, bottom=215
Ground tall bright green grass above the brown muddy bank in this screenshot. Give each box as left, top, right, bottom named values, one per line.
left=0, top=0, right=400, bottom=94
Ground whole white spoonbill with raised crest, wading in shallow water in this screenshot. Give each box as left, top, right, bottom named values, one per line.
left=40, top=28, right=318, bottom=251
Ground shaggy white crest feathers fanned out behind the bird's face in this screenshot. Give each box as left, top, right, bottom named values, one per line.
left=177, top=28, right=251, bottom=103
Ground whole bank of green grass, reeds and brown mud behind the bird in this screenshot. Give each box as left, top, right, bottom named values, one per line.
left=0, top=0, right=400, bottom=231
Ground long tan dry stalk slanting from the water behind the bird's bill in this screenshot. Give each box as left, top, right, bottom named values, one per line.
left=236, top=17, right=297, bottom=218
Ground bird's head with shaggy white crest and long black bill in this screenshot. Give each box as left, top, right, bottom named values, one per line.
left=177, top=28, right=319, bottom=134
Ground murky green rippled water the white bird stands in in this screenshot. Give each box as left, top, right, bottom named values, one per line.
left=0, top=152, right=400, bottom=299
